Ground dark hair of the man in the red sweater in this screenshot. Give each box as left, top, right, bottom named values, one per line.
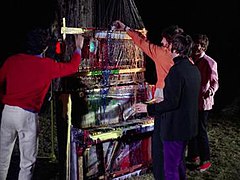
left=24, top=27, right=50, bottom=55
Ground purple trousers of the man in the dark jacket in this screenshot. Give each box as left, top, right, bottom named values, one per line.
left=163, top=141, right=187, bottom=180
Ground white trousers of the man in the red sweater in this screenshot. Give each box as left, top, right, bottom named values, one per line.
left=0, top=105, right=38, bottom=180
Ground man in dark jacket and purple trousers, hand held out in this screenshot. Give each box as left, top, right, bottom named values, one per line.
left=135, top=34, right=201, bottom=180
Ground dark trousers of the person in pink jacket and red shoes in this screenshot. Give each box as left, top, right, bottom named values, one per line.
left=187, top=111, right=210, bottom=163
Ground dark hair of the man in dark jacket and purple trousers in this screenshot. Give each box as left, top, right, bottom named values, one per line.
left=171, top=33, right=193, bottom=57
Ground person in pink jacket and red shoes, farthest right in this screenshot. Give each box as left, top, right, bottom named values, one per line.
left=187, top=34, right=219, bottom=172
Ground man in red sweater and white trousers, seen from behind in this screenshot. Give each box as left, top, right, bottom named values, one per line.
left=0, top=28, right=84, bottom=180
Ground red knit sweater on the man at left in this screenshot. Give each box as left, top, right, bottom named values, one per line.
left=0, top=52, right=81, bottom=112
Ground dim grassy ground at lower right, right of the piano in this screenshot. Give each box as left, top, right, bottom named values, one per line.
left=133, top=102, right=240, bottom=180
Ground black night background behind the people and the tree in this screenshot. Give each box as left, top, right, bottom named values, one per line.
left=0, top=0, right=240, bottom=110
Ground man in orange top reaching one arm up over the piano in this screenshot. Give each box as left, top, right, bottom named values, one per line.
left=113, top=20, right=184, bottom=180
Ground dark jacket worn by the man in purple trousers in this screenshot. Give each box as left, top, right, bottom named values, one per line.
left=147, top=57, right=201, bottom=141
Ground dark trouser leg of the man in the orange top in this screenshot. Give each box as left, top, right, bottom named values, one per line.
left=152, top=118, right=164, bottom=180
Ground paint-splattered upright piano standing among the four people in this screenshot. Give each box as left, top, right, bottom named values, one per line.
left=54, top=30, right=153, bottom=180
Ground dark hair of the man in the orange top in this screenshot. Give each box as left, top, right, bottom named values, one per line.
left=162, top=25, right=184, bottom=43
